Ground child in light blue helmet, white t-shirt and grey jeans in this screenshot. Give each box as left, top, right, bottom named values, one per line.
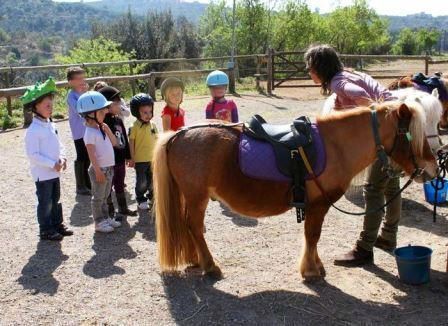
left=76, top=91, right=121, bottom=233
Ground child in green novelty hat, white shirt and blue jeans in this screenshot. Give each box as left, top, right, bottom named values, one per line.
left=21, top=78, right=73, bottom=241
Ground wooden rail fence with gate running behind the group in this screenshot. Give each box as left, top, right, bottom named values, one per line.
left=0, top=49, right=448, bottom=115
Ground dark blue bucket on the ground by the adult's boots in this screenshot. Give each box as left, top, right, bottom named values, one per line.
left=394, top=245, right=432, bottom=285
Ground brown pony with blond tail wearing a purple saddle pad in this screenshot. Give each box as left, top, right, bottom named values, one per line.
left=153, top=101, right=437, bottom=281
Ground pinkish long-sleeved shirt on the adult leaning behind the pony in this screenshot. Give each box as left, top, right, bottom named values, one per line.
left=330, top=70, right=395, bottom=109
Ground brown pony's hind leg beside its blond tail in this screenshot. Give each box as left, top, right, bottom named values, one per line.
left=187, top=201, right=222, bottom=279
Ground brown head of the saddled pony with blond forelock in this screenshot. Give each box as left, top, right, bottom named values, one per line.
left=380, top=101, right=438, bottom=182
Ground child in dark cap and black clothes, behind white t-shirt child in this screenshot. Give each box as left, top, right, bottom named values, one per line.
left=99, top=86, right=137, bottom=221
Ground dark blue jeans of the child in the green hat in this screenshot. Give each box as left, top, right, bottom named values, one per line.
left=36, top=178, right=62, bottom=233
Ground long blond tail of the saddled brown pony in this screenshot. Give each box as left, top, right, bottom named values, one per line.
left=153, top=132, right=191, bottom=271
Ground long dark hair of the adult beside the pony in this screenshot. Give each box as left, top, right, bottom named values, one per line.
left=304, top=44, right=344, bottom=95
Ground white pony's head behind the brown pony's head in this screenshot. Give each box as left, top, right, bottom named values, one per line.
left=392, top=88, right=442, bottom=153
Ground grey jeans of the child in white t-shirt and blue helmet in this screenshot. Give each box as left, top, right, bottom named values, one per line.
left=89, top=165, right=114, bottom=223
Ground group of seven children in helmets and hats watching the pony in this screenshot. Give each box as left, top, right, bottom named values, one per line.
left=21, top=67, right=238, bottom=241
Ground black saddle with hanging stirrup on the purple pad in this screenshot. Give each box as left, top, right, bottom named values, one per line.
left=243, top=115, right=316, bottom=223
